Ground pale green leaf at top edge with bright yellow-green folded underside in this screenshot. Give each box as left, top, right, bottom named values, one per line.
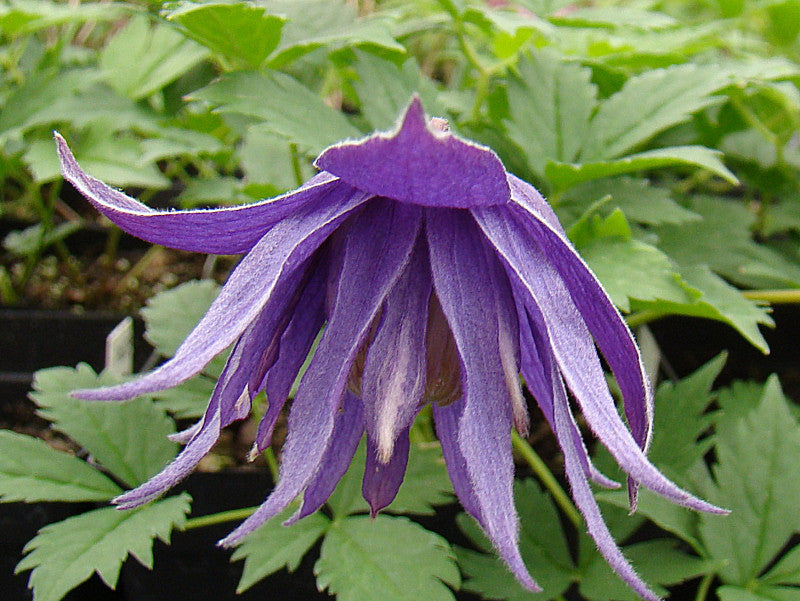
left=261, top=0, right=406, bottom=68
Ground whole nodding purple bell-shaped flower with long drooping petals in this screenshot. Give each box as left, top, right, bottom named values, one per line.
left=56, top=97, right=721, bottom=599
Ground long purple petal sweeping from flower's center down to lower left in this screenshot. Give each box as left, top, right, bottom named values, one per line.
left=220, top=199, right=422, bottom=547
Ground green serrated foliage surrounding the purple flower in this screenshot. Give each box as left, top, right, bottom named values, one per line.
left=0, top=0, right=800, bottom=601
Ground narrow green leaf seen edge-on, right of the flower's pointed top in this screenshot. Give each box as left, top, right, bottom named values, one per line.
left=545, top=146, right=739, bottom=190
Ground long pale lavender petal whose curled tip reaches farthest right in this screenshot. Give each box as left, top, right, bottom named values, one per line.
left=473, top=210, right=724, bottom=513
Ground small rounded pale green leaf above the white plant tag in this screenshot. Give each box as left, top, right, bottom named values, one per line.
left=141, top=280, right=220, bottom=357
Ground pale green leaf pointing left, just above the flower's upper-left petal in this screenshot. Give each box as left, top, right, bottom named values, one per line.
left=189, top=72, right=361, bottom=154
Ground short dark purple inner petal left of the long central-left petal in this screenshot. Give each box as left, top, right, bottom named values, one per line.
left=253, top=264, right=327, bottom=453
